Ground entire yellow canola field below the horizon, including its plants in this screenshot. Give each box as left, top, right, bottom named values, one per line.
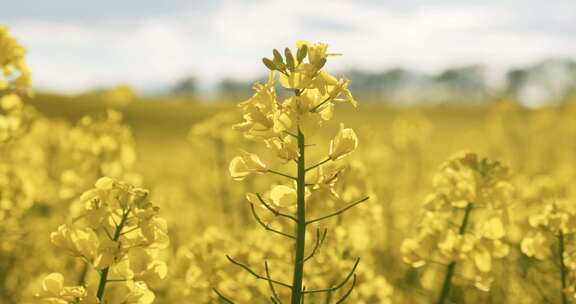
left=0, top=27, right=576, bottom=304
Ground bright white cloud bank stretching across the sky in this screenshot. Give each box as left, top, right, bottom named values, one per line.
left=11, top=0, right=576, bottom=91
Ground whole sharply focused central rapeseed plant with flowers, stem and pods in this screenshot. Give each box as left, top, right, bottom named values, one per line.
left=216, top=42, right=368, bottom=304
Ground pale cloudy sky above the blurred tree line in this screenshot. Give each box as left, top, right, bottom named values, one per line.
left=0, top=0, right=576, bottom=93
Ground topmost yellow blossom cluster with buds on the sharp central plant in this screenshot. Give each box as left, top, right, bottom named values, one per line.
left=234, top=42, right=357, bottom=142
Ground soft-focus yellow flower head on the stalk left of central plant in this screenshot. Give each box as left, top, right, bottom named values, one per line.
left=38, top=177, right=169, bottom=304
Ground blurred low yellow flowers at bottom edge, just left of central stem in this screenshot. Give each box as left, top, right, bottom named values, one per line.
left=167, top=227, right=288, bottom=303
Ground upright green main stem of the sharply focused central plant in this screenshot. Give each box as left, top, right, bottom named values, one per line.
left=291, top=129, right=306, bottom=304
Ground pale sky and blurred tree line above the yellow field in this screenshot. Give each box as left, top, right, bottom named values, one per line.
left=0, top=0, right=576, bottom=107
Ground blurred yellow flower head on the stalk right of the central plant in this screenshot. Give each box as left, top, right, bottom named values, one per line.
left=401, top=153, right=511, bottom=290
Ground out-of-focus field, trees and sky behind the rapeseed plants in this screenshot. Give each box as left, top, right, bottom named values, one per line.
left=0, top=0, right=576, bottom=304
